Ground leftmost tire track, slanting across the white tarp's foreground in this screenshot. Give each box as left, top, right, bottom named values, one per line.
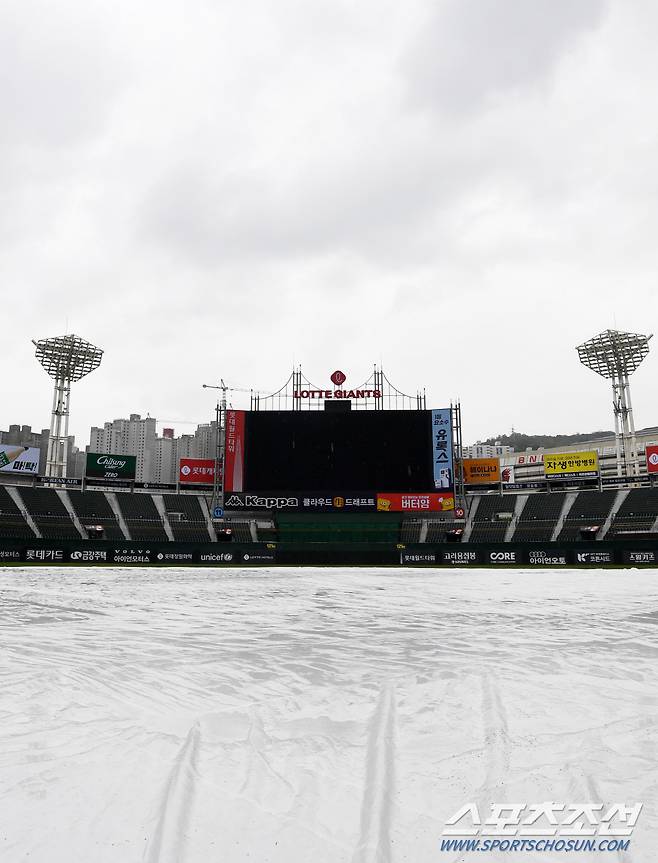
left=143, top=721, right=201, bottom=863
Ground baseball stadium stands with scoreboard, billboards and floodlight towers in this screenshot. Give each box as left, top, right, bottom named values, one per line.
left=0, top=330, right=658, bottom=567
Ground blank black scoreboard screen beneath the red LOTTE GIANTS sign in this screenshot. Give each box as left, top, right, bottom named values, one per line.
left=244, top=410, right=434, bottom=492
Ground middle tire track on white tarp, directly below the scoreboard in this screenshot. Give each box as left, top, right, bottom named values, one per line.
left=352, top=686, right=396, bottom=863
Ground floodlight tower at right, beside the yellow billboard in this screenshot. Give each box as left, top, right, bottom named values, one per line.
left=576, top=330, right=652, bottom=476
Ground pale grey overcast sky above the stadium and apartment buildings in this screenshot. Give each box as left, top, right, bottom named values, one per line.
left=0, top=0, right=658, bottom=446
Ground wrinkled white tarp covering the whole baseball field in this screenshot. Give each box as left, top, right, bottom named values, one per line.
left=0, top=568, right=658, bottom=863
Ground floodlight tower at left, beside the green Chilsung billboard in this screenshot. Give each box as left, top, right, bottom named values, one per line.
left=32, top=335, right=103, bottom=477
